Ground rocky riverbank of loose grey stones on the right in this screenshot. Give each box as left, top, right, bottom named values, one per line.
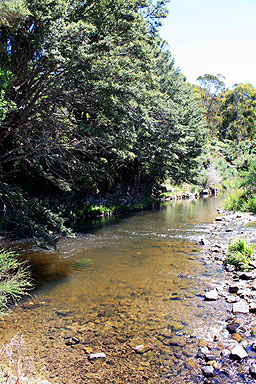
left=196, top=209, right=256, bottom=383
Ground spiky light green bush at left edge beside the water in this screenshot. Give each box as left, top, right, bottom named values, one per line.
left=0, top=249, right=31, bottom=314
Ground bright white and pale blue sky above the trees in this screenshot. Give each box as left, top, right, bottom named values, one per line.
left=160, top=0, right=256, bottom=87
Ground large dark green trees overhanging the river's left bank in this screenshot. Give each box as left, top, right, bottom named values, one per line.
left=0, top=0, right=205, bottom=246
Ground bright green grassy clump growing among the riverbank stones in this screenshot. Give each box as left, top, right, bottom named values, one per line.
left=225, top=238, right=255, bottom=271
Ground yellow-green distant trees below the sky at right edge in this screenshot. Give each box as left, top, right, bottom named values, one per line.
left=194, top=74, right=256, bottom=143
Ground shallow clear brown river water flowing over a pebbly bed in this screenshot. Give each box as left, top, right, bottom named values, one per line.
left=0, top=198, right=232, bottom=384
